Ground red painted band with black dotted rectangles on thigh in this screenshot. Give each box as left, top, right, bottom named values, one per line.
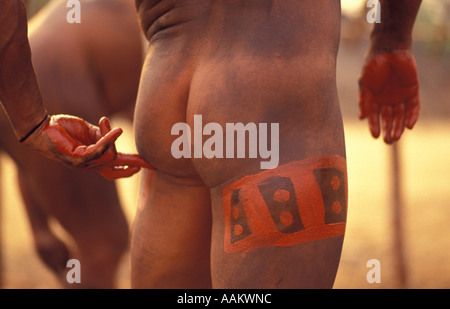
left=223, top=155, right=347, bottom=253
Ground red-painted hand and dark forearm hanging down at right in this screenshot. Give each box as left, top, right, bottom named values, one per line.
left=359, top=0, right=422, bottom=144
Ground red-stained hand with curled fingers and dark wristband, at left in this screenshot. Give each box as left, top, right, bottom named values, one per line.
left=23, top=115, right=152, bottom=180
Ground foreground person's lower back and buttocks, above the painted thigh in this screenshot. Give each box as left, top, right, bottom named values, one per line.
left=136, top=0, right=344, bottom=183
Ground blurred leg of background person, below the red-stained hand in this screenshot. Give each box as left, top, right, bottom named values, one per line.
left=19, top=155, right=128, bottom=288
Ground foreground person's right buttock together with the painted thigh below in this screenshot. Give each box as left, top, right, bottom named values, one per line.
left=187, top=59, right=347, bottom=288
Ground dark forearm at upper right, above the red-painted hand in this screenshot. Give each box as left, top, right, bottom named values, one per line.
left=371, top=0, right=422, bottom=51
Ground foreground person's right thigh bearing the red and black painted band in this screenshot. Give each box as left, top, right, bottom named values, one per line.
left=211, top=155, right=347, bottom=288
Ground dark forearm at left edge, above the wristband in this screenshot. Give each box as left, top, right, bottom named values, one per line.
left=0, top=0, right=47, bottom=139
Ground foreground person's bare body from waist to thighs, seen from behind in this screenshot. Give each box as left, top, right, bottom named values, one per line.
left=132, top=0, right=346, bottom=288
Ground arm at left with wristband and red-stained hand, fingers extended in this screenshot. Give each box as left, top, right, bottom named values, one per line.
left=0, top=0, right=148, bottom=179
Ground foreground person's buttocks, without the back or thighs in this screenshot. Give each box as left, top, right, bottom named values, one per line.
left=135, top=50, right=344, bottom=183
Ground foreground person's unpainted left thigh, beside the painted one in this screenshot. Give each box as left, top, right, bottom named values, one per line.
left=131, top=171, right=211, bottom=288
